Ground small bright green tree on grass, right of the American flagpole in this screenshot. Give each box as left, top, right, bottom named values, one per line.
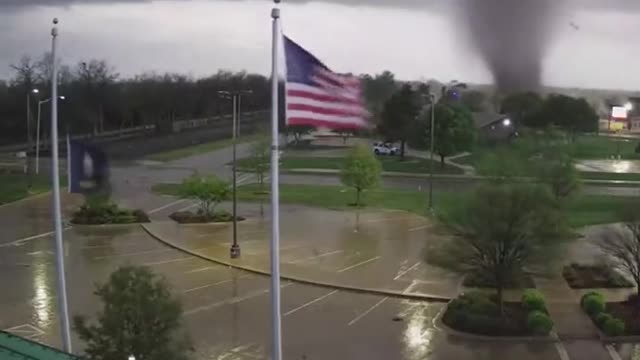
left=341, top=145, right=382, bottom=206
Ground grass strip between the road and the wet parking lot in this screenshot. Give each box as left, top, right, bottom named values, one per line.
left=153, top=184, right=638, bottom=227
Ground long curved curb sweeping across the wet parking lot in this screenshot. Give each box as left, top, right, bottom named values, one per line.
left=140, top=224, right=451, bottom=303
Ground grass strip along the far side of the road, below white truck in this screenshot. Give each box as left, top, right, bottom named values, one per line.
left=238, top=155, right=464, bottom=174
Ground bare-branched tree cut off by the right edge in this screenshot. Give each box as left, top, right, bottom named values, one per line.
left=595, top=219, right=640, bottom=298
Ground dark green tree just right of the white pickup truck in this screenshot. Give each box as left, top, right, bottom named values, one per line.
left=379, top=85, right=421, bottom=158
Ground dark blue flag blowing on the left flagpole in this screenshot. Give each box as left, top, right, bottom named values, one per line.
left=67, top=140, right=109, bottom=193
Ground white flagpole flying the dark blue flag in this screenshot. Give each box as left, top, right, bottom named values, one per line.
left=51, top=19, right=71, bottom=353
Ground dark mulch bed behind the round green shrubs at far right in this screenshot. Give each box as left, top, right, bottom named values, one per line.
left=562, top=264, right=634, bottom=289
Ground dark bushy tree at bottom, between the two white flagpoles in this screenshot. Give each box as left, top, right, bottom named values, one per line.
left=73, top=266, right=191, bottom=360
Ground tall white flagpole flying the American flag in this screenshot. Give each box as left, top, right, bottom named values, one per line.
left=271, top=0, right=282, bottom=360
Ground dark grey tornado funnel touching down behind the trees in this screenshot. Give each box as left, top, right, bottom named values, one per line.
left=463, top=0, right=556, bottom=93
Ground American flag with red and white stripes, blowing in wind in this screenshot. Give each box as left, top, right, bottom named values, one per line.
left=284, top=36, right=369, bottom=129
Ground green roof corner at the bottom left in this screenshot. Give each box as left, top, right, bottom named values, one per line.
left=0, top=331, right=80, bottom=360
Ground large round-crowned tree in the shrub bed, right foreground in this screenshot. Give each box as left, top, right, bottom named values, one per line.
left=427, top=184, right=567, bottom=313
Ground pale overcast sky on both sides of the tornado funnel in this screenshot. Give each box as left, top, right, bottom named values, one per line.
left=0, top=0, right=640, bottom=89
